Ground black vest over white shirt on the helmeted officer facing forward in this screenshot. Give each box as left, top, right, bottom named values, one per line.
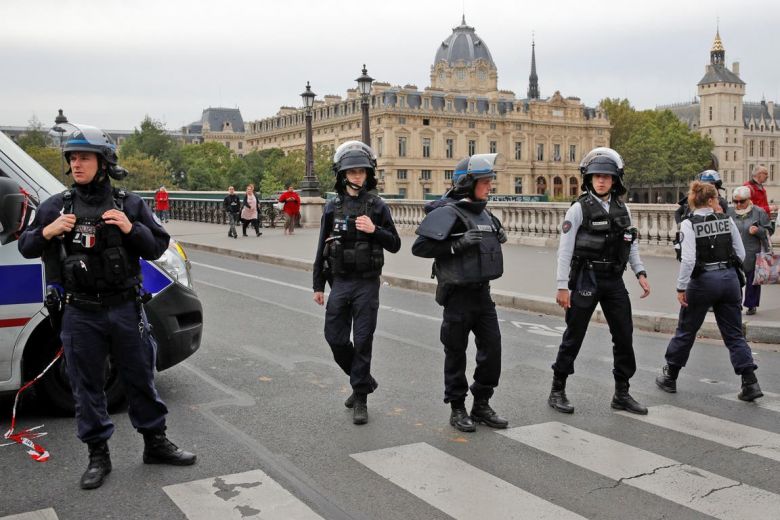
left=574, top=193, right=635, bottom=272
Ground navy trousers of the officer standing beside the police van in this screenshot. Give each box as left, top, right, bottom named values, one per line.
left=60, top=301, right=168, bottom=443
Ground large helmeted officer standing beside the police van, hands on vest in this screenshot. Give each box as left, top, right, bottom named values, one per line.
left=19, top=125, right=195, bottom=489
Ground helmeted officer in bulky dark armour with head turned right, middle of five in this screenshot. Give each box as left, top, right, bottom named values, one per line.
left=412, top=154, right=509, bottom=432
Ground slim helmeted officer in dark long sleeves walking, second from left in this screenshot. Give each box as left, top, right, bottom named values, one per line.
left=313, top=141, right=401, bottom=424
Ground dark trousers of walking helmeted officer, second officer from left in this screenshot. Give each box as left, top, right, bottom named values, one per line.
left=325, top=276, right=379, bottom=394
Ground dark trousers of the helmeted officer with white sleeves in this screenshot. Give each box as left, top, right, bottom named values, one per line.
left=552, top=273, right=636, bottom=382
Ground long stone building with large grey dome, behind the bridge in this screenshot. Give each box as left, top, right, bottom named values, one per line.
left=241, top=18, right=610, bottom=199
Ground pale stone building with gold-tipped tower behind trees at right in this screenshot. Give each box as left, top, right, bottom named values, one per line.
left=658, top=31, right=780, bottom=201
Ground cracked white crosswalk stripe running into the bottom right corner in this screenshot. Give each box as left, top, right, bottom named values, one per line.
left=499, top=422, right=780, bottom=520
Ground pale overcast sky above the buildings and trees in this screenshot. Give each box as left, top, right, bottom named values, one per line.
left=0, top=0, right=780, bottom=130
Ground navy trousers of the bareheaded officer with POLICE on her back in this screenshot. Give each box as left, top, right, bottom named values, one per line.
left=666, top=269, right=756, bottom=375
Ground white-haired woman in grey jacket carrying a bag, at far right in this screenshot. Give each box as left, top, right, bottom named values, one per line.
left=728, top=186, right=772, bottom=316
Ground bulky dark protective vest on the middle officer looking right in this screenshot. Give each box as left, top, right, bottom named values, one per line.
left=434, top=204, right=504, bottom=285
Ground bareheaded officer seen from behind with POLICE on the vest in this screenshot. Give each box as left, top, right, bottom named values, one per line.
left=655, top=181, right=764, bottom=401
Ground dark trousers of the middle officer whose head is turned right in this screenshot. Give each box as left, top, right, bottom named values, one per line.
left=441, top=283, right=501, bottom=403
